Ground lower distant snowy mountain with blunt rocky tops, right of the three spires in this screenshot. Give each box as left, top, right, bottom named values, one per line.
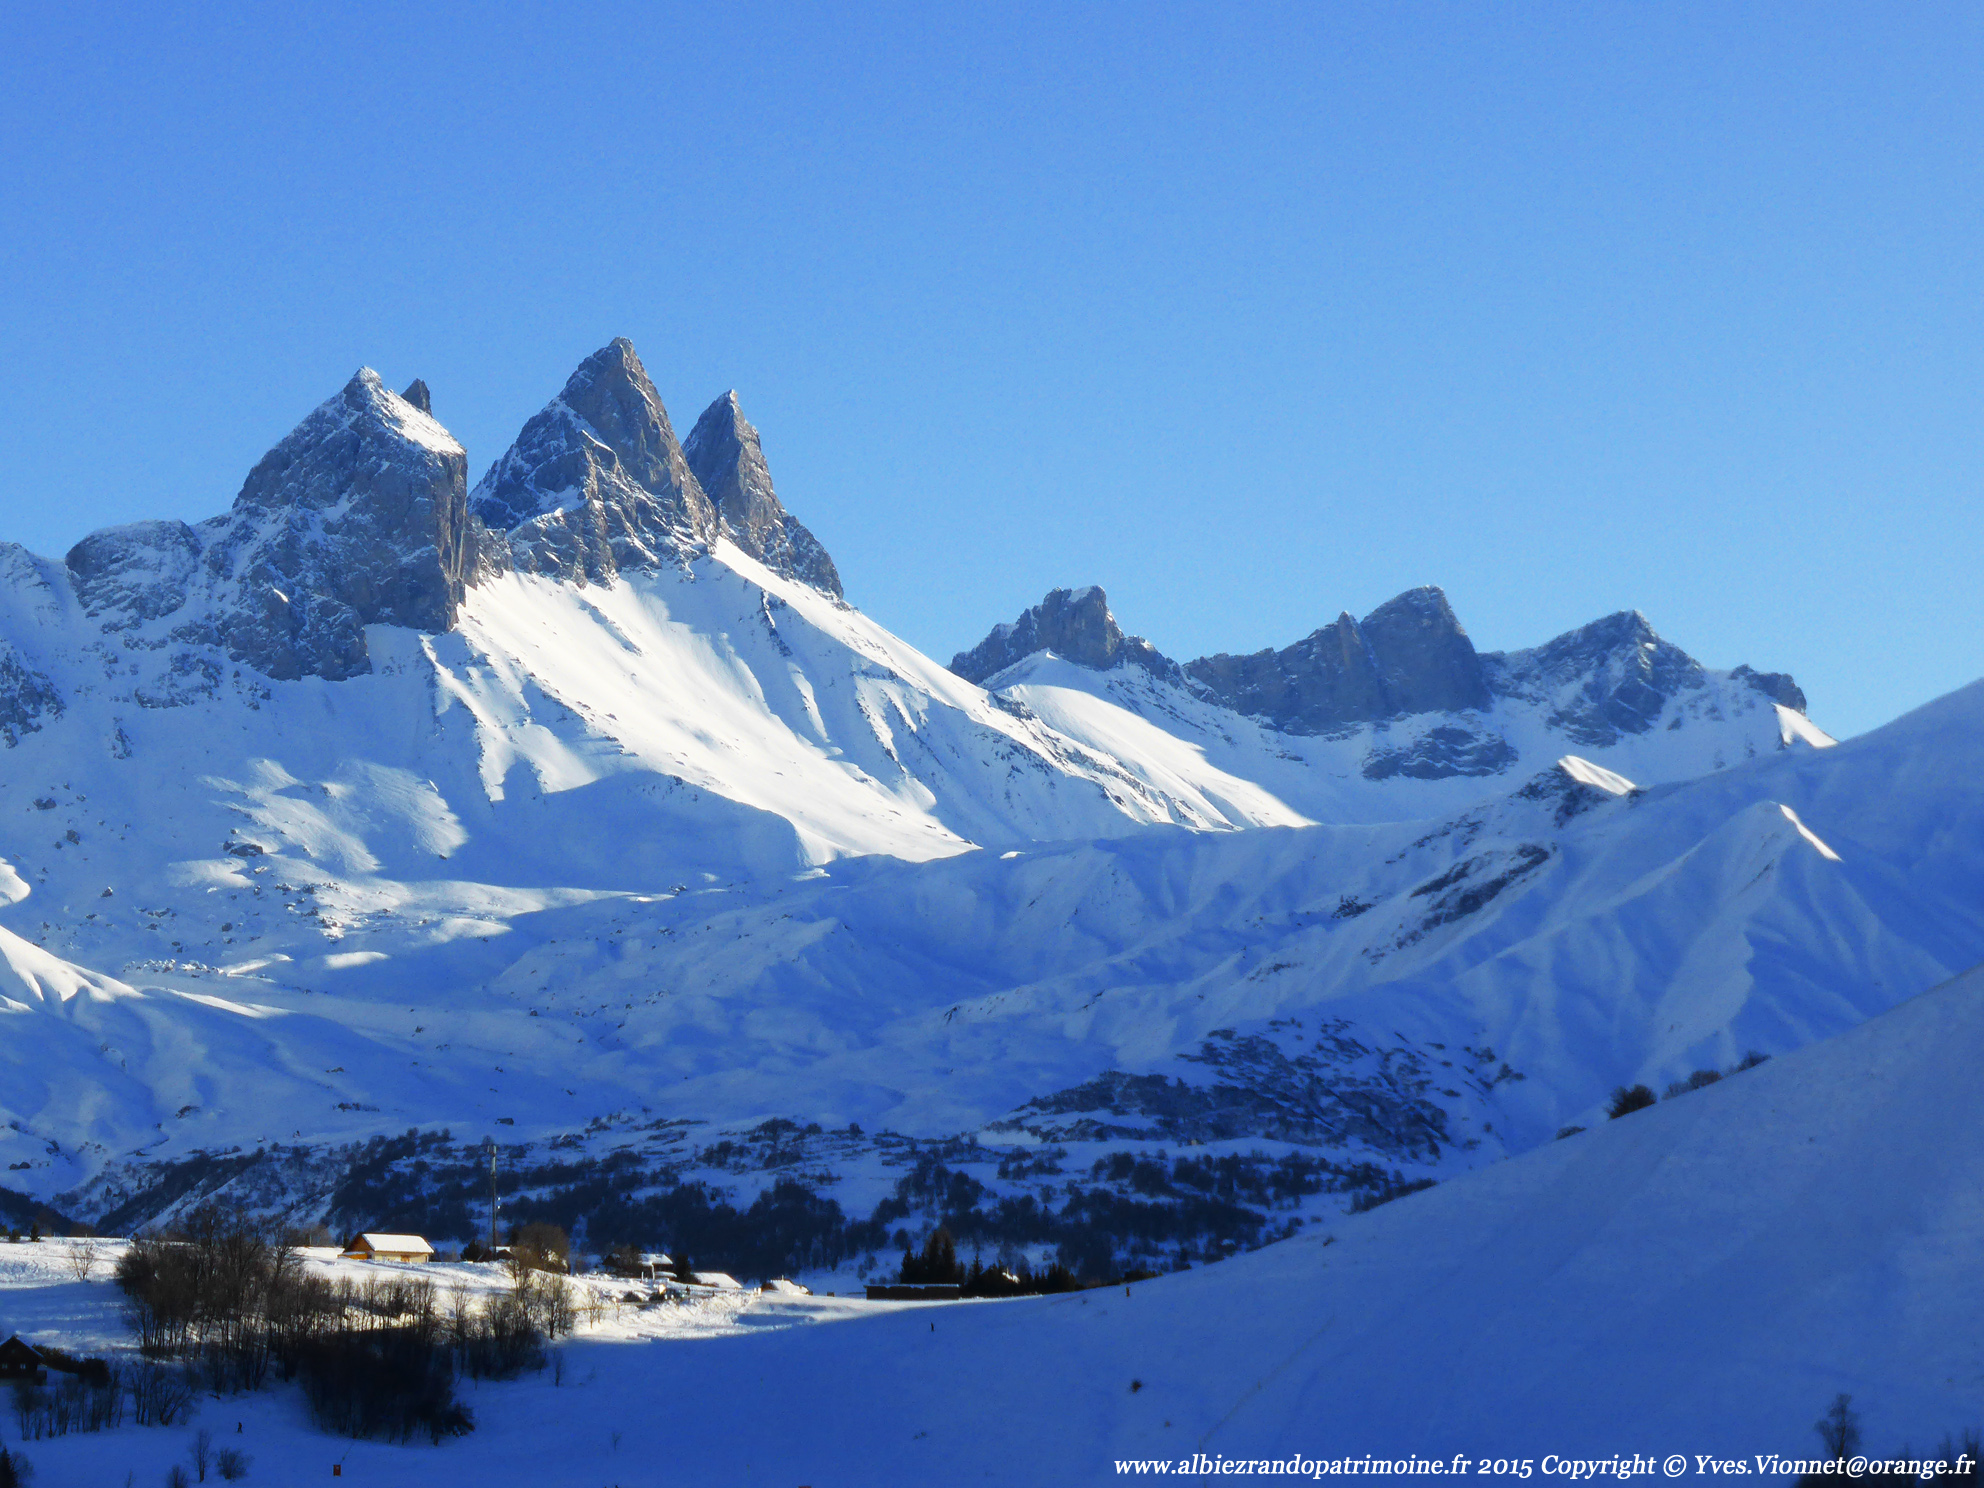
left=950, top=587, right=1831, bottom=821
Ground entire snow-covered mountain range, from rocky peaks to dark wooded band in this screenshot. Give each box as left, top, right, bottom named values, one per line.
left=0, top=341, right=1984, bottom=1277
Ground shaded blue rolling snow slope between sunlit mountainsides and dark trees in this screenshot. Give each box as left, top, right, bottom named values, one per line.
left=6, top=686, right=1984, bottom=1245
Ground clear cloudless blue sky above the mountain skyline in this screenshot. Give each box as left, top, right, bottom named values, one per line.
left=0, top=0, right=1984, bottom=734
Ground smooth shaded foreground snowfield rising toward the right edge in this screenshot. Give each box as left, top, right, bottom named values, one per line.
left=0, top=960, right=1984, bottom=1488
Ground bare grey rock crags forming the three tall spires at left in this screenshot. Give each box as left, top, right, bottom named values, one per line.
left=38, top=339, right=841, bottom=698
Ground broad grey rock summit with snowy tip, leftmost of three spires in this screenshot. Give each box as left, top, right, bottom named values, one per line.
left=196, top=367, right=468, bottom=679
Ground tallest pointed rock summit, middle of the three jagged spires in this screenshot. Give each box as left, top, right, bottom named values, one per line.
left=468, top=337, right=716, bottom=583
